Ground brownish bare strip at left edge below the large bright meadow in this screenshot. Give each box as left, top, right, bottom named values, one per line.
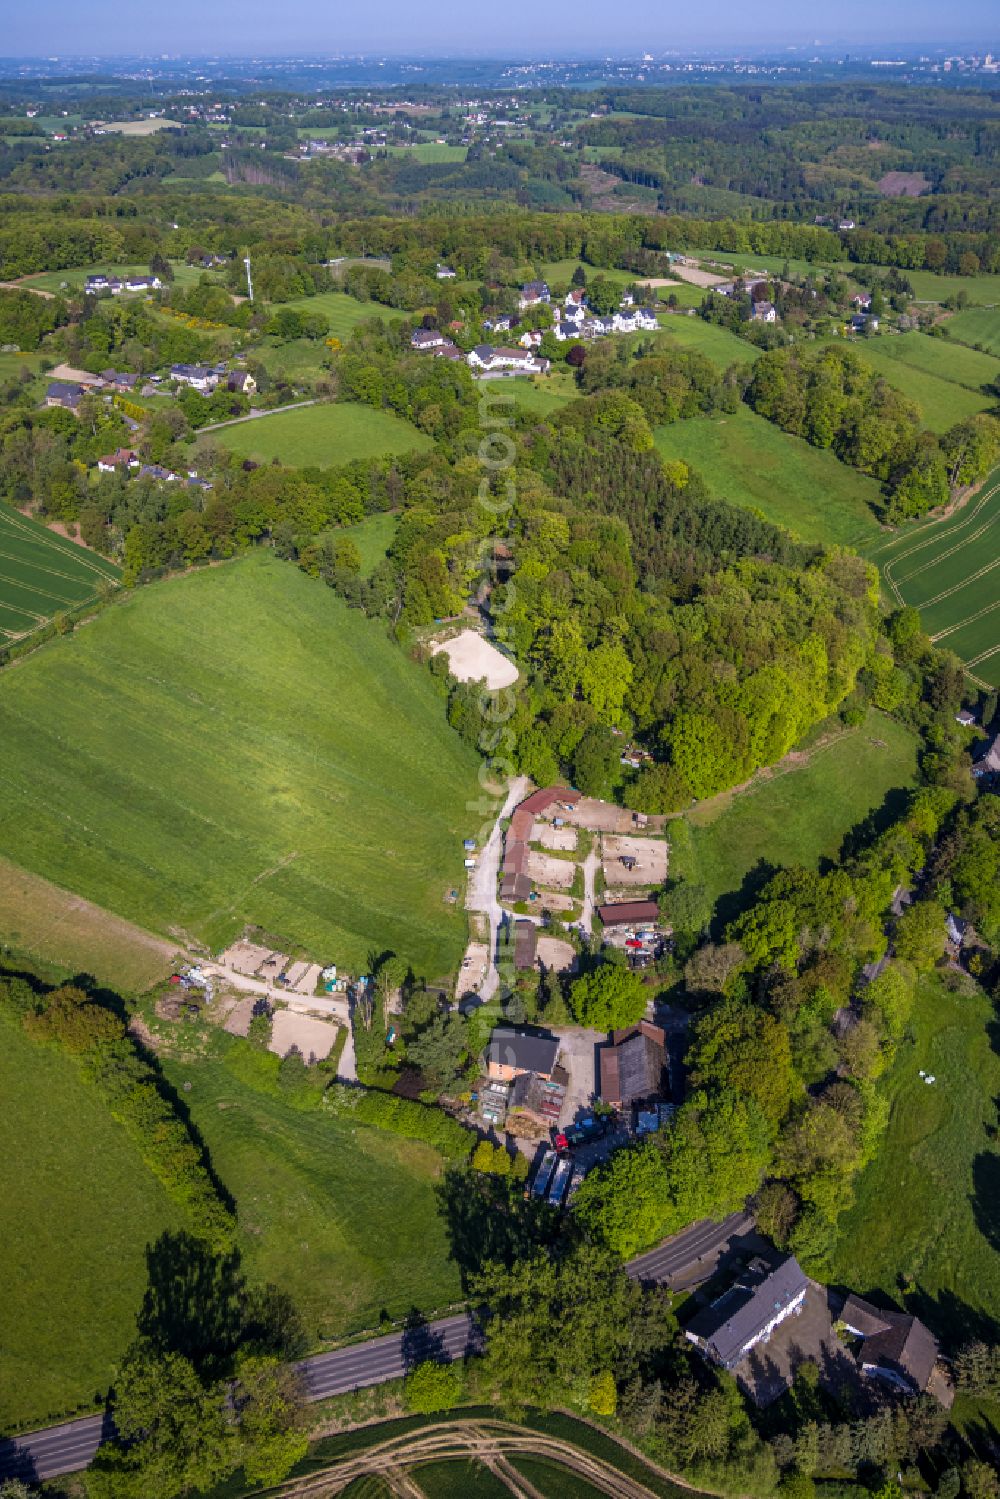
left=0, top=859, right=183, bottom=994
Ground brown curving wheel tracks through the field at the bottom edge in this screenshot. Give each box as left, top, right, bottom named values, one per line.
left=271, top=1420, right=701, bottom=1499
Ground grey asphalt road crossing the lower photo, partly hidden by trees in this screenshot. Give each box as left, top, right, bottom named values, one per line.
left=0, top=1213, right=754, bottom=1483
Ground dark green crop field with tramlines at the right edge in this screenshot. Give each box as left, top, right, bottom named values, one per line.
left=865, top=469, right=1000, bottom=687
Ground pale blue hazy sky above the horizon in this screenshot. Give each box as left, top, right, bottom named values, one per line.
left=0, top=0, right=1000, bottom=58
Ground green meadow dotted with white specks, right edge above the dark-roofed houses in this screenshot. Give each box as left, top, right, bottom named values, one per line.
left=831, top=976, right=1000, bottom=1352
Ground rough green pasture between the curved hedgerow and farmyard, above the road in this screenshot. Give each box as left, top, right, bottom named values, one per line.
left=163, top=1027, right=462, bottom=1346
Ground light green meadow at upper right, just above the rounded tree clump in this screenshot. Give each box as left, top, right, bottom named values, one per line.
left=837, top=333, right=1000, bottom=432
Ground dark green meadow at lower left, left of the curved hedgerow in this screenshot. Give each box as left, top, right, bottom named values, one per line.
left=0, top=1019, right=180, bottom=1432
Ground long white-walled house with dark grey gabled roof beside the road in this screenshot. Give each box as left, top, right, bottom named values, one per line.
left=684, top=1255, right=810, bottom=1370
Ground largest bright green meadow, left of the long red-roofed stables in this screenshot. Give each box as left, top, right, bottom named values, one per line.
left=0, top=552, right=478, bottom=977
